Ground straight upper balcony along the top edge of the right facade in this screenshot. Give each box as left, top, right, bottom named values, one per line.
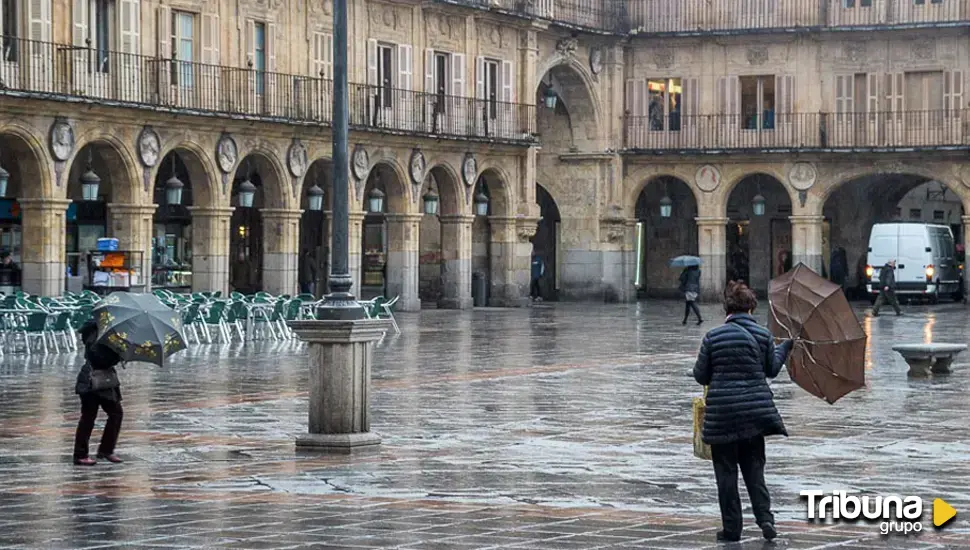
left=628, top=0, right=970, bottom=35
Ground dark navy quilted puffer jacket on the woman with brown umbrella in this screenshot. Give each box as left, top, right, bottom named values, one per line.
left=694, top=314, right=792, bottom=445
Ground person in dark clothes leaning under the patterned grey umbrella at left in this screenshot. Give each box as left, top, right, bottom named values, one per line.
left=74, top=321, right=124, bottom=466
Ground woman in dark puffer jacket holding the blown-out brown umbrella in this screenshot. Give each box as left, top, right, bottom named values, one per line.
left=694, top=281, right=792, bottom=542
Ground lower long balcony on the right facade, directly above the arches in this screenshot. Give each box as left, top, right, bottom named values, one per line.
left=624, top=110, right=970, bottom=154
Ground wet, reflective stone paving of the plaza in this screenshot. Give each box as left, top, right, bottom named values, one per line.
left=0, top=303, right=970, bottom=550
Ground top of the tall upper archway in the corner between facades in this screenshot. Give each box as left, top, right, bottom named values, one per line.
left=533, top=51, right=604, bottom=144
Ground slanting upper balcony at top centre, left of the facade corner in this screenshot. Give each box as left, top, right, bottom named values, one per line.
left=436, top=0, right=629, bottom=35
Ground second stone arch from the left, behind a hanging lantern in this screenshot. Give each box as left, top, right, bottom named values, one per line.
left=64, top=133, right=144, bottom=206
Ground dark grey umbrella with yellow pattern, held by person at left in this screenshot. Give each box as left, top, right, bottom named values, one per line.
left=93, top=292, right=186, bottom=366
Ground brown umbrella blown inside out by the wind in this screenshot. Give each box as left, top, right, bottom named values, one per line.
left=768, top=263, right=866, bottom=404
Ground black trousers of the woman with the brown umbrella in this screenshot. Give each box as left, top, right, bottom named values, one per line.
left=711, top=436, right=775, bottom=535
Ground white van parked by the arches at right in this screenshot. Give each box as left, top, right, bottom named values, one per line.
left=866, top=223, right=960, bottom=303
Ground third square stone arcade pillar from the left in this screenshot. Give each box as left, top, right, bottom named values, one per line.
left=189, top=206, right=233, bottom=296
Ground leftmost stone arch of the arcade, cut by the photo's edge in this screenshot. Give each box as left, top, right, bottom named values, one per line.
left=0, top=122, right=51, bottom=199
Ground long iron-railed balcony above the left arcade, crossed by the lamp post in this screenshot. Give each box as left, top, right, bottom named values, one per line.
left=0, top=37, right=535, bottom=148
